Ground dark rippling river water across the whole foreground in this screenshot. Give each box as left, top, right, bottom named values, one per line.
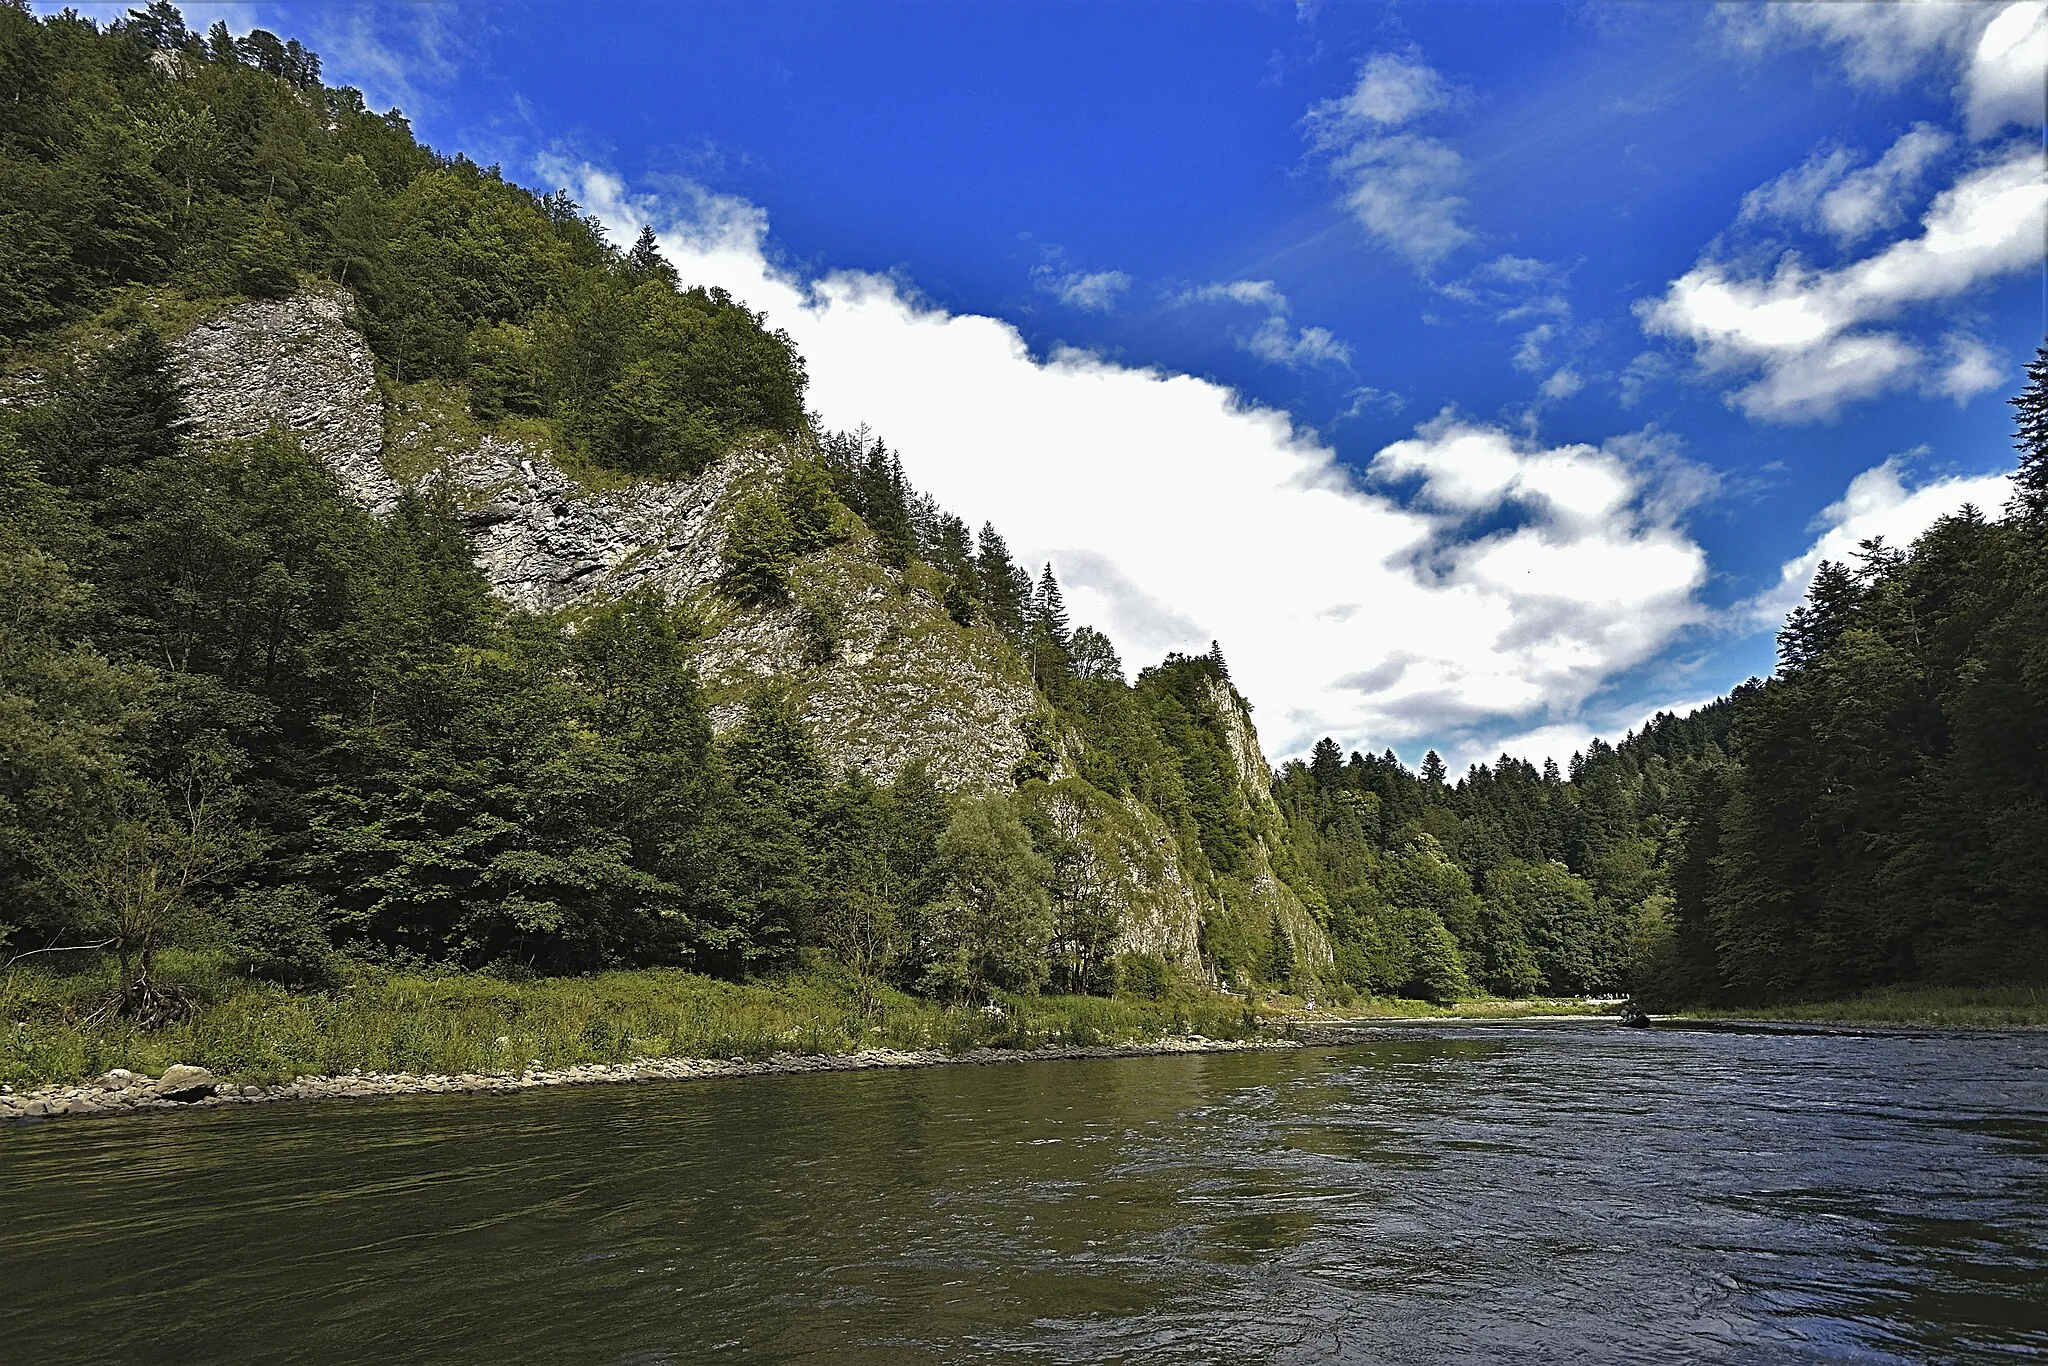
left=0, top=1024, right=2048, bottom=1366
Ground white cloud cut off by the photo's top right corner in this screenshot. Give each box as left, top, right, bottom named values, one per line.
left=1720, top=0, right=2048, bottom=139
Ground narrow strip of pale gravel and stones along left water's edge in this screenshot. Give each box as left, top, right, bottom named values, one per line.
left=0, top=1036, right=1300, bottom=1122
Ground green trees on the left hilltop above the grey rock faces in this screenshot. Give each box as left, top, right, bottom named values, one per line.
left=0, top=0, right=805, bottom=477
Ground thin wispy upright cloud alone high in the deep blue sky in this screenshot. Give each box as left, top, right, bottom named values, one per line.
left=1309, top=53, right=1475, bottom=270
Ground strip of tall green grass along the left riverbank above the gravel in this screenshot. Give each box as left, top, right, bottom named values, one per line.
left=0, top=954, right=1255, bottom=1087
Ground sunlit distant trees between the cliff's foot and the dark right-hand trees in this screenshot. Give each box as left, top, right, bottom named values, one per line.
left=1274, top=702, right=1731, bottom=1001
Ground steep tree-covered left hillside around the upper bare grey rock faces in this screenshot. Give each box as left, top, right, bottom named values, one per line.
left=0, top=4, right=1327, bottom=1016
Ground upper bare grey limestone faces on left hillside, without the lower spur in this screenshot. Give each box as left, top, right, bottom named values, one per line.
left=176, top=291, right=1042, bottom=788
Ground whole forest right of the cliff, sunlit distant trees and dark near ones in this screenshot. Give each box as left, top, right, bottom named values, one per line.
left=1276, top=348, right=2048, bottom=1006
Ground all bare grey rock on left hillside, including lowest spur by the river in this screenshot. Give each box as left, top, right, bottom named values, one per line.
left=176, top=291, right=1329, bottom=975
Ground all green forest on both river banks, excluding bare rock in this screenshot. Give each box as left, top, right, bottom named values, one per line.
left=0, top=0, right=2048, bottom=1018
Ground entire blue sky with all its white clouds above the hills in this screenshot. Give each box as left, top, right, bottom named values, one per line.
left=68, top=0, right=2048, bottom=764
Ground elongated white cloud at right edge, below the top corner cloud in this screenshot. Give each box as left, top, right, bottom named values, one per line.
left=1636, top=141, right=2048, bottom=422
